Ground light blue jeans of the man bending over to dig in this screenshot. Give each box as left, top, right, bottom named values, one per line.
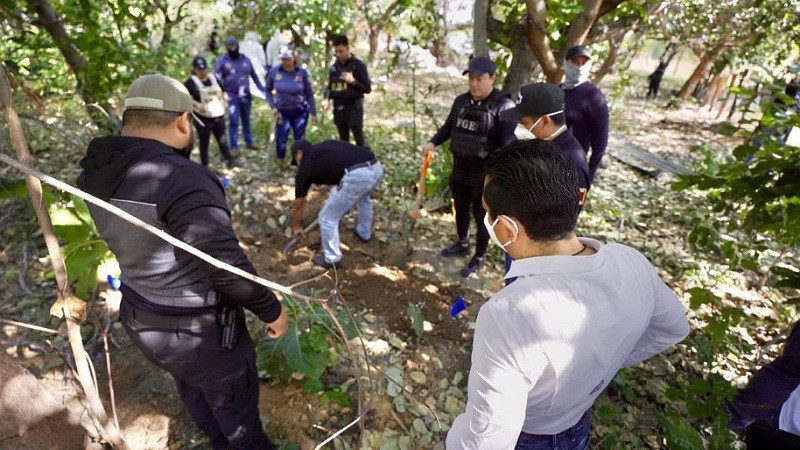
left=319, top=163, right=383, bottom=263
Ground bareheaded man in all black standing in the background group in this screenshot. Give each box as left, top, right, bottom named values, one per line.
left=322, top=34, right=372, bottom=146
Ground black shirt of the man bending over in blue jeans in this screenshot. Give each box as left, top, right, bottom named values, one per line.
left=294, top=140, right=375, bottom=198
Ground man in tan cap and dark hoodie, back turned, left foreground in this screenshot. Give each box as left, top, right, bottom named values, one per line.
left=78, top=75, right=288, bottom=450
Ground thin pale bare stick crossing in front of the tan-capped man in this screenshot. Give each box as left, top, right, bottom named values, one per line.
left=0, top=153, right=318, bottom=302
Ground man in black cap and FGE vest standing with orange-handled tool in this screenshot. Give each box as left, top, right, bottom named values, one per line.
left=422, top=57, right=517, bottom=278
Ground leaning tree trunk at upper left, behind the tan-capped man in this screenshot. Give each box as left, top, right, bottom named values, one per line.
left=26, top=0, right=121, bottom=133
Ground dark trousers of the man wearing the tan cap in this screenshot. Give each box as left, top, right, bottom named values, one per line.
left=120, top=300, right=275, bottom=450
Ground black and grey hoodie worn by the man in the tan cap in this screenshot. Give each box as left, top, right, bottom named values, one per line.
left=78, top=136, right=281, bottom=322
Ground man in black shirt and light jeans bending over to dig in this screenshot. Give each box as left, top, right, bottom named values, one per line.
left=292, top=139, right=383, bottom=269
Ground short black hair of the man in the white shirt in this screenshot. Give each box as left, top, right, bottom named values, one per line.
left=483, top=139, right=581, bottom=242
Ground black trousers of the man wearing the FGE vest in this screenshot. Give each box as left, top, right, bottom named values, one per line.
left=450, top=174, right=489, bottom=258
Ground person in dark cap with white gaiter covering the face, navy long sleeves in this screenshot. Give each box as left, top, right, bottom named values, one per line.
left=561, top=45, right=608, bottom=181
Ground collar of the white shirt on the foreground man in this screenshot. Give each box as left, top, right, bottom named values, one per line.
left=506, top=238, right=604, bottom=278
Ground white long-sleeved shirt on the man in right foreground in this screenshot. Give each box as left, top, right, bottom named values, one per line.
left=447, top=238, right=689, bottom=450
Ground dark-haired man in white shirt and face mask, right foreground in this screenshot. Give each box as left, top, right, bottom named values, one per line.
left=447, top=140, right=689, bottom=450
